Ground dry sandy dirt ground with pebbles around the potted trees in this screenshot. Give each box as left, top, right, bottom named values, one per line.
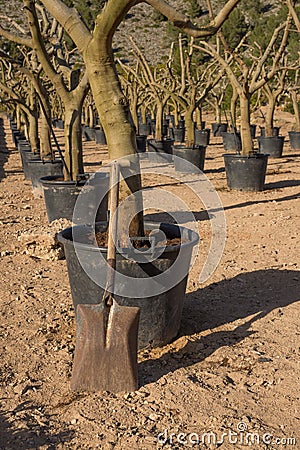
left=0, top=113, right=300, bottom=450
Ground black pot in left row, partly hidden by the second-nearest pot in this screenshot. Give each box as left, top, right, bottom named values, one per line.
left=28, top=158, right=63, bottom=198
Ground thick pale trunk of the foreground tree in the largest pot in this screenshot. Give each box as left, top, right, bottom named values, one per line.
left=84, top=40, right=144, bottom=239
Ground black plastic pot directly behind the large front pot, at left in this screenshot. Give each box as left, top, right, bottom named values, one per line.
left=40, top=173, right=109, bottom=224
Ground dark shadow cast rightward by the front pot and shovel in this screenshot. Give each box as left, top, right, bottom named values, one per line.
left=139, top=269, right=300, bottom=385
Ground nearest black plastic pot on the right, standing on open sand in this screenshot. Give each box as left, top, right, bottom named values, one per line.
left=223, top=153, right=268, bottom=191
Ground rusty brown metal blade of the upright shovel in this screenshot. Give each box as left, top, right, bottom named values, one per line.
left=71, top=299, right=140, bottom=392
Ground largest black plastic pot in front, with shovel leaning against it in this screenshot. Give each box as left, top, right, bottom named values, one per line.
left=58, top=222, right=199, bottom=349
